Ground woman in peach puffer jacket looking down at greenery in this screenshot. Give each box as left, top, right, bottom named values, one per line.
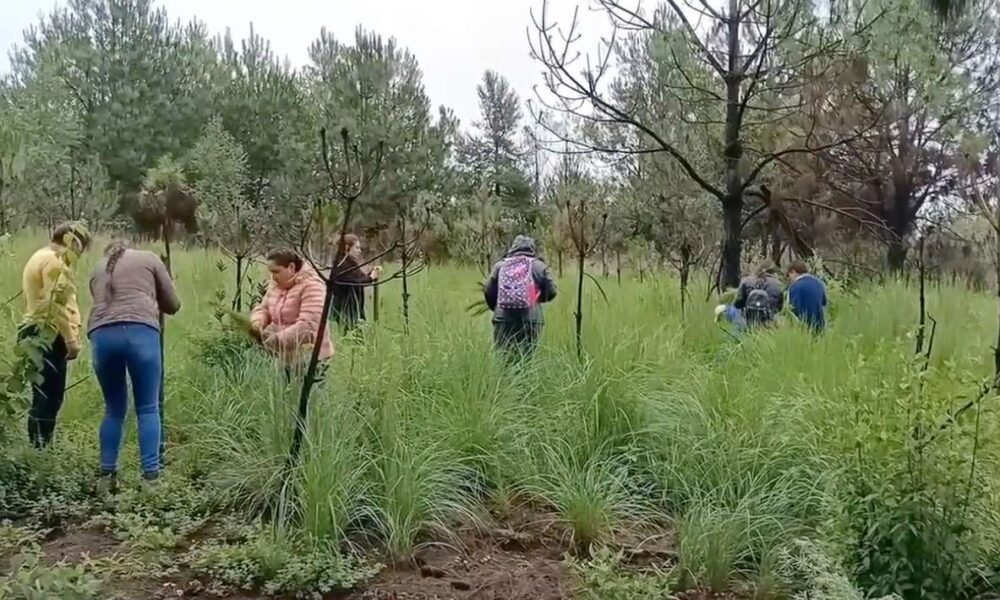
left=250, top=250, right=333, bottom=368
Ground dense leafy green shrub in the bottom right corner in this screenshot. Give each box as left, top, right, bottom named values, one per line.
left=836, top=346, right=992, bottom=599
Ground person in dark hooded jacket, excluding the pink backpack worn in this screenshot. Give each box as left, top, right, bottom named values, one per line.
left=483, top=235, right=556, bottom=355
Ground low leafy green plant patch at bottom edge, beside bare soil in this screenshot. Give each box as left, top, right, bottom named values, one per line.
left=567, top=547, right=676, bottom=600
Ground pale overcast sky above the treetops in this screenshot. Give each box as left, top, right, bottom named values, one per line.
left=0, top=0, right=606, bottom=127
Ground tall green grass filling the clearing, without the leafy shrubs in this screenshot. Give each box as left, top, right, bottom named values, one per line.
left=0, top=231, right=1000, bottom=597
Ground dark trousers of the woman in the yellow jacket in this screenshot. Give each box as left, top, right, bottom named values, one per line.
left=17, top=327, right=69, bottom=448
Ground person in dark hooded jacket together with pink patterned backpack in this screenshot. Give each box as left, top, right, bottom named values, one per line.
left=483, top=235, right=556, bottom=356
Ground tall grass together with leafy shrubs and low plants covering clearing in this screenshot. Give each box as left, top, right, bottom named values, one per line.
left=0, top=233, right=1000, bottom=600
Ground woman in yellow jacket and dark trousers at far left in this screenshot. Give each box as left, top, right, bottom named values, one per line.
left=18, top=223, right=90, bottom=448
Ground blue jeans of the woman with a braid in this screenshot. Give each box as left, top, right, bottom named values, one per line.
left=90, top=323, right=161, bottom=476
